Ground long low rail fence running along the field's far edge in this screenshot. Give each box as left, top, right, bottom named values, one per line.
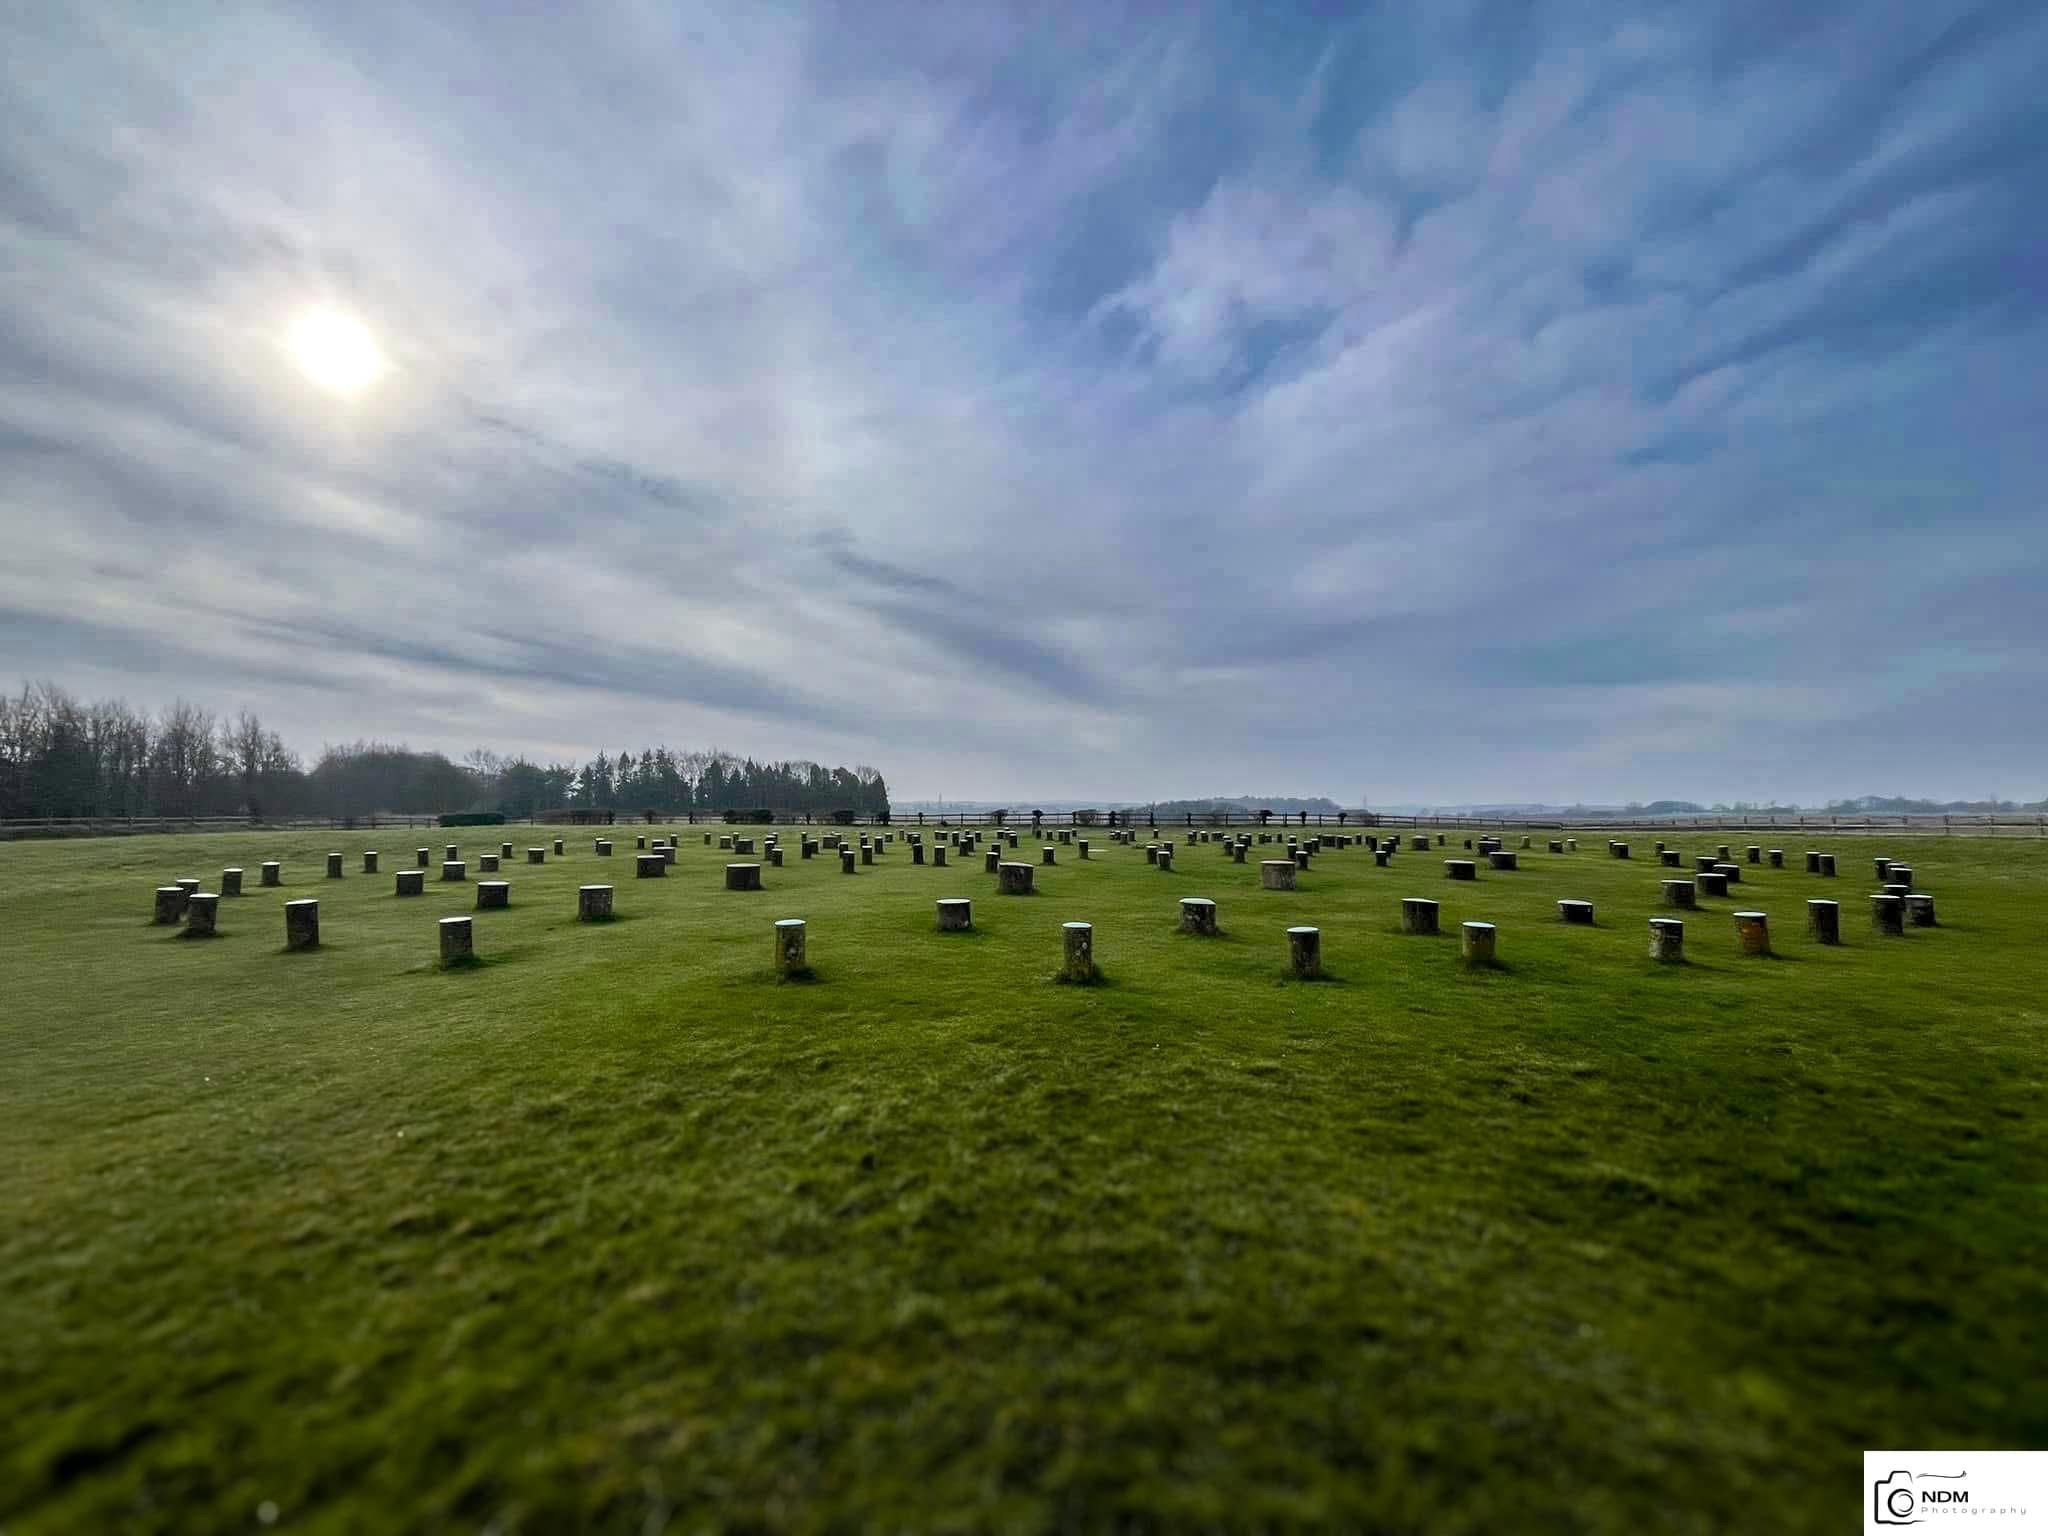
left=0, top=811, right=2048, bottom=842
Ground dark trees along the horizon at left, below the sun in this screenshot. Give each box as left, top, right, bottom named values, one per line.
left=0, top=682, right=889, bottom=819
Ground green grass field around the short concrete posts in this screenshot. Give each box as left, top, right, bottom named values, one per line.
left=0, top=827, right=2048, bottom=1536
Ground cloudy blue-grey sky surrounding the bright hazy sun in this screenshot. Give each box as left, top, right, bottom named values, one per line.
left=0, top=0, right=2048, bottom=805
